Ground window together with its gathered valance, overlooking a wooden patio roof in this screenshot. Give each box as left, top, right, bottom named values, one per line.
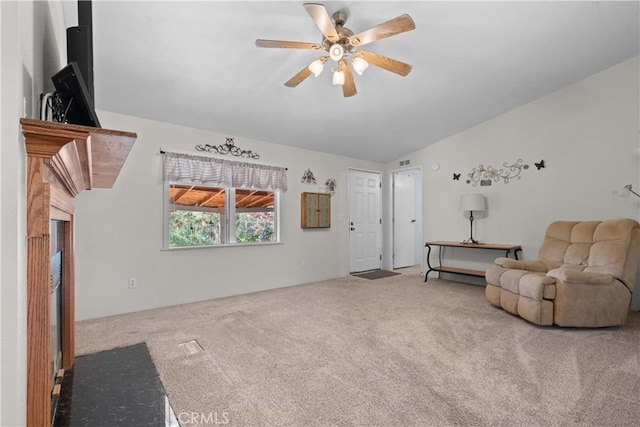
left=164, top=153, right=286, bottom=248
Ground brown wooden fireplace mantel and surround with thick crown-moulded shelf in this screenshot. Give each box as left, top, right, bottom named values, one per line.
left=20, top=119, right=137, bottom=426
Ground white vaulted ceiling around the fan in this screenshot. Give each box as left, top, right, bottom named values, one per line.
left=65, top=0, right=640, bottom=162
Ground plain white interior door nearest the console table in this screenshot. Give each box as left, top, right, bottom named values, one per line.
left=393, top=170, right=417, bottom=268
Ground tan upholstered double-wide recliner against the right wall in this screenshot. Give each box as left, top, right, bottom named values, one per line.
left=485, top=219, right=640, bottom=327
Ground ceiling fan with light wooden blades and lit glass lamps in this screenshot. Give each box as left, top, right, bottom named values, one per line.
left=256, top=3, right=416, bottom=97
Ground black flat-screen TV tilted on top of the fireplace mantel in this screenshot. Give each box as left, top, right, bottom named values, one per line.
left=51, top=62, right=100, bottom=128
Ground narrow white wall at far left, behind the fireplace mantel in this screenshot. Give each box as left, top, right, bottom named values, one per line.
left=0, top=1, right=64, bottom=426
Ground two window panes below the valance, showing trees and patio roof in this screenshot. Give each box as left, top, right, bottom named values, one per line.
left=167, top=184, right=278, bottom=247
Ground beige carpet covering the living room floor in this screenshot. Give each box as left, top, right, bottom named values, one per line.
left=76, top=269, right=640, bottom=426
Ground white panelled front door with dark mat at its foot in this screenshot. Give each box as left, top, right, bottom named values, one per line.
left=349, top=169, right=382, bottom=273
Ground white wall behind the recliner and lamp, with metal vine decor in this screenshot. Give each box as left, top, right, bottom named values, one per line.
left=387, top=57, right=640, bottom=308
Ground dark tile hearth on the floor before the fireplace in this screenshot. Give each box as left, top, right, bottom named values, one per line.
left=53, top=343, right=173, bottom=427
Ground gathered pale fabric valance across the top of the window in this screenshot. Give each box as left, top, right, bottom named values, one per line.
left=164, top=152, right=287, bottom=191
